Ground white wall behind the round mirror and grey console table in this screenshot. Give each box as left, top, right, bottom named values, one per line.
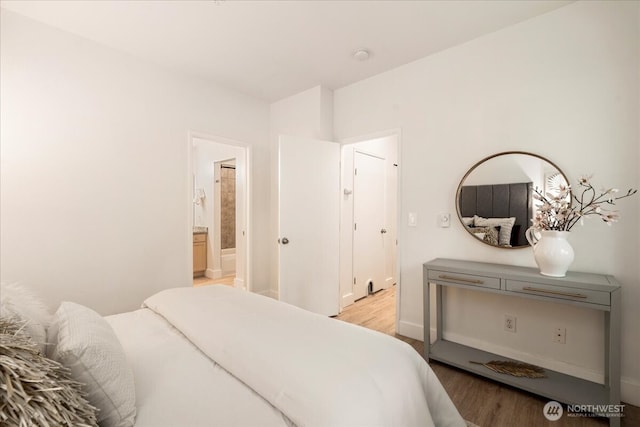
left=334, top=1, right=640, bottom=405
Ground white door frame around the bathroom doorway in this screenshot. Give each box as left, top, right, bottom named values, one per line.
left=185, top=130, right=253, bottom=291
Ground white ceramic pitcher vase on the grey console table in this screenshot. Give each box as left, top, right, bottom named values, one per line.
left=526, top=227, right=574, bottom=277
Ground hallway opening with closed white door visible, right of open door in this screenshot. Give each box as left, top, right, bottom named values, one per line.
left=340, top=131, right=399, bottom=318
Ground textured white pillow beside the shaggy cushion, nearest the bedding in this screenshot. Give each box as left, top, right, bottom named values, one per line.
left=48, top=302, right=136, bottom=427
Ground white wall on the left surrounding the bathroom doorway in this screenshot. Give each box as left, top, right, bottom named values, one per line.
left=0, top=9, right=270, bottom=314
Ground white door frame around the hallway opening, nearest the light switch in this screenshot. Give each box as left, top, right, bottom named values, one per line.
left=340, top=128, right=402, bottom=332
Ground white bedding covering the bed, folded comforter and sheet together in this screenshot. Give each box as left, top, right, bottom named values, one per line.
left=107, top=286, right=466, bottom=427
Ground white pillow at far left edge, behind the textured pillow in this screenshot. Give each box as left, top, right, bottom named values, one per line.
left=0, top=283, right=52, bottom=354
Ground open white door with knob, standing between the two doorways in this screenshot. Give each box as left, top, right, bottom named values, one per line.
left=278, top=135, right=340, bottom=316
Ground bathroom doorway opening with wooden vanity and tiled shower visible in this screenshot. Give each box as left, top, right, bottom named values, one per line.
left=191, top=135, right=249, bottom=289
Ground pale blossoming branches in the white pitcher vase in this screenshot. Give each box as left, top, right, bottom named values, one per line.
left=533, top=175, right=638, bottom=231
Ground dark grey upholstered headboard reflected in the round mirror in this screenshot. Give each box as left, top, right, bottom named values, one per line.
left=458, top=182, right=533, bottom=246
